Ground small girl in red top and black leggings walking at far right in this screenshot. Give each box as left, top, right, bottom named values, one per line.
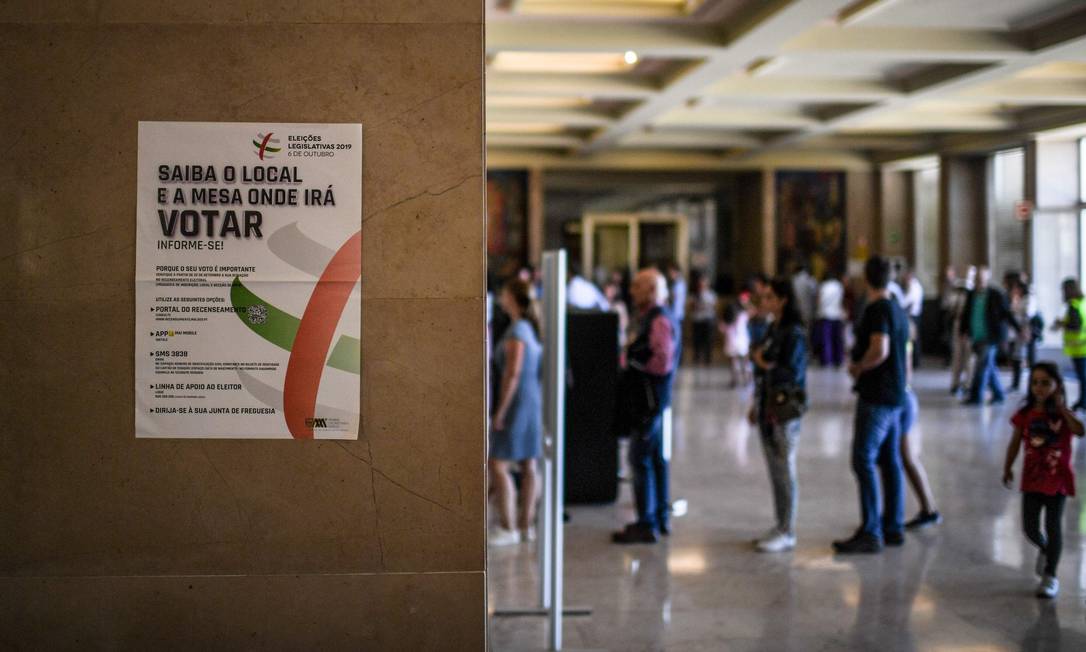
left=1003, top=362, right=1083, bottom=598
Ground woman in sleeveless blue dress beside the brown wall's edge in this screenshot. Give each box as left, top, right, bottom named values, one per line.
left=489, top=278, right=543, bottom=546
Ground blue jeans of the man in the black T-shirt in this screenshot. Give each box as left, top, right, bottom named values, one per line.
left=853, top=401, right=905, bottom=539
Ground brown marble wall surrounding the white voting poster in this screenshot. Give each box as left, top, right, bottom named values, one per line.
left=0, top=0, right=485, bottom=650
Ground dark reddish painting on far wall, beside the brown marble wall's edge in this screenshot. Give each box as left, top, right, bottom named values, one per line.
left=487, top=171, right=528, bottom=280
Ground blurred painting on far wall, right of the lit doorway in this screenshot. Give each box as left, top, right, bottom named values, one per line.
left=776, top=172, right=847, bottom=278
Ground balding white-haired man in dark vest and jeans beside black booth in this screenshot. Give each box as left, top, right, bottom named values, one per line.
left=611, top=268, right=678, bottom=543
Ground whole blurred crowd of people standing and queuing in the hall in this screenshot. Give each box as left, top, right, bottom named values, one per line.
left=490, top=252, right=1086, bottom=598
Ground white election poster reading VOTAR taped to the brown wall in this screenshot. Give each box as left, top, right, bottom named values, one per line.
left=135, top=122, right=362, bottom=439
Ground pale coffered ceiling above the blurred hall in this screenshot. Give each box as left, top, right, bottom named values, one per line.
left=487, top=0, right=1086, bottom=167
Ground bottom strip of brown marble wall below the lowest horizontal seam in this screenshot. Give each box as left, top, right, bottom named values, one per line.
left=0, top=573, right=485, bottom=652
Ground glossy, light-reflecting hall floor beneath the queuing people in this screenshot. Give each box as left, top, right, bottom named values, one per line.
left=490, top=368, right=1086, bottom=652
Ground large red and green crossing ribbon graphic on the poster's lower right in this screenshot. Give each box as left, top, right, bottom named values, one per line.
left=230, top=231, right=362, bottom=439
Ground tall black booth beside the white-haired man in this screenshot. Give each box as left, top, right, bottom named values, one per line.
left=566, top=309, right=619, bottom=504
